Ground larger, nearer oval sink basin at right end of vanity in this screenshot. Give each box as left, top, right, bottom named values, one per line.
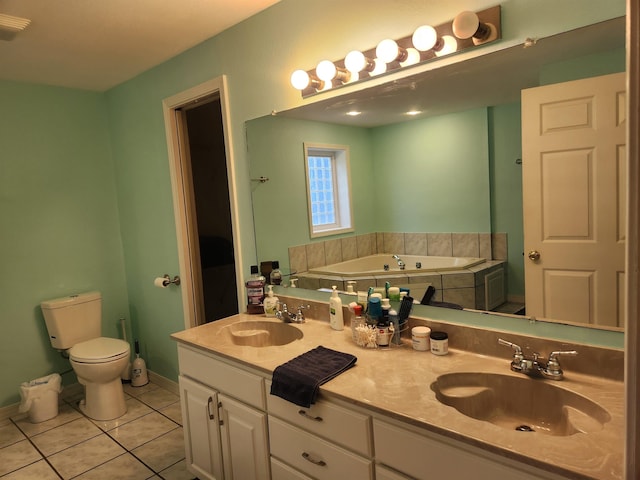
left=431, top=372, right=611, bottom=436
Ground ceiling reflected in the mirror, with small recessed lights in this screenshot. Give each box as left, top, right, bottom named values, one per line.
left=277, top=17, right=625, bottom=127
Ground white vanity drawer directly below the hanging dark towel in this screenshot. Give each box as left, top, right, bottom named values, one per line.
left=265, top=380, right=373, bottom=457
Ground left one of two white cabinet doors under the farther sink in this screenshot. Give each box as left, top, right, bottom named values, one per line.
left=179, top=375, right=224, bottom=480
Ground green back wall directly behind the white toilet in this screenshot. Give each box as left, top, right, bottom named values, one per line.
left=0, top=81, right=129, bottom=405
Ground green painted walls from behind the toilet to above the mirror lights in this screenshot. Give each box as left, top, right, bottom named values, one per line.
left=0, top=0, right=625, bottom=406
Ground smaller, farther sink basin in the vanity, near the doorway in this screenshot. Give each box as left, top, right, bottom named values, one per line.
left=220, top=320, right=302, bottom=347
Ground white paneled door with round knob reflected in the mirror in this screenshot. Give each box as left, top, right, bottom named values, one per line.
left=522, top=73, right=626, bottom=327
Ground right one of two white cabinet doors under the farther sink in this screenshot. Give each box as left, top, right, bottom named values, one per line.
left=218, top=394, right=270, bottom=480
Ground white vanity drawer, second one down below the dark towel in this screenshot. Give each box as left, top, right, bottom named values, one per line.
left=269, top=415, right=373, bottom=480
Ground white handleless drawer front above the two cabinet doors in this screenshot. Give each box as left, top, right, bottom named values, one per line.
left=178, top=344, right=266, bottom=410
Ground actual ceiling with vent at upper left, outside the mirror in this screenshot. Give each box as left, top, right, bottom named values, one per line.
left=0, top=0, right=279, bottom=91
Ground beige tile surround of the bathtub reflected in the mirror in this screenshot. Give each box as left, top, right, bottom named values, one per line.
left=289, top=232, right=507, bottom=310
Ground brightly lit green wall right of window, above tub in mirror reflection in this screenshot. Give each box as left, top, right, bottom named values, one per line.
left=371, top=108, right=491, bottom=233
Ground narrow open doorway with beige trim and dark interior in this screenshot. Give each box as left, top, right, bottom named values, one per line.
left=163, top=76, right=242, bottom=328
